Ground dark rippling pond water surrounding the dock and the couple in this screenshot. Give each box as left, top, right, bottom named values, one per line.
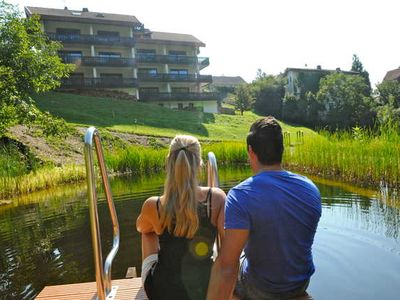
left=0, top=170, right=400, bottom=299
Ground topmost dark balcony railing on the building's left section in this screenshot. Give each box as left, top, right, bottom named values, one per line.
left=47, top=32, right=135, bottom=46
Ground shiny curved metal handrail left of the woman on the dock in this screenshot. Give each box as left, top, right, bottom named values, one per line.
left=84, top=127, right=120, bottom=300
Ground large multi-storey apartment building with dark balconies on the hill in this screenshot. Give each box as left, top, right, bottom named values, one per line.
left=25, top=7, right=218, bottom=113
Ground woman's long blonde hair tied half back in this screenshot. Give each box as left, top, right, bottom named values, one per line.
left=160, top=135, right=202, bottom=238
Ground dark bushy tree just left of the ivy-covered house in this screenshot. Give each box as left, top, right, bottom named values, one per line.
left=251, top=74, right=286, bottom=118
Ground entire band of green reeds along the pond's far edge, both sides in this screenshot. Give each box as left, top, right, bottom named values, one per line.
left=0, top=126, right=400, bottom=199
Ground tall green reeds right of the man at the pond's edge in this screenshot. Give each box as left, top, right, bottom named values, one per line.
left=285, top=126, right=400, bottom=187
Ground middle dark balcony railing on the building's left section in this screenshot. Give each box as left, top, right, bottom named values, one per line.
left=60, top=55, right=135, bottom=67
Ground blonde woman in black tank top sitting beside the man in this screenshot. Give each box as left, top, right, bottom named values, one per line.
left=136, top=135, right=226, bottom=300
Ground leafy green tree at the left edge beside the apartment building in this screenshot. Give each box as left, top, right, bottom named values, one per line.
left=0, top=1, right=73, bottom=136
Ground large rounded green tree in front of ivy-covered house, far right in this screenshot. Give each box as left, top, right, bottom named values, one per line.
left=316, top=73, right=374, bottom=129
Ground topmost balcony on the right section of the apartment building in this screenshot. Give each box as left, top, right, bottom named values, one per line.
left=136, top=53, right=210, bottom=69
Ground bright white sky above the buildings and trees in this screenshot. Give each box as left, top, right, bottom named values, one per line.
left=7, top=0, right=400, bottom=87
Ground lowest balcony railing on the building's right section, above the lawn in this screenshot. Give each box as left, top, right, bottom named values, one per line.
left=139, top=93, right=220, bottom=102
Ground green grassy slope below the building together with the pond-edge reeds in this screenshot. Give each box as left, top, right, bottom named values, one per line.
left=0, top=93, right=400, bottom=198
